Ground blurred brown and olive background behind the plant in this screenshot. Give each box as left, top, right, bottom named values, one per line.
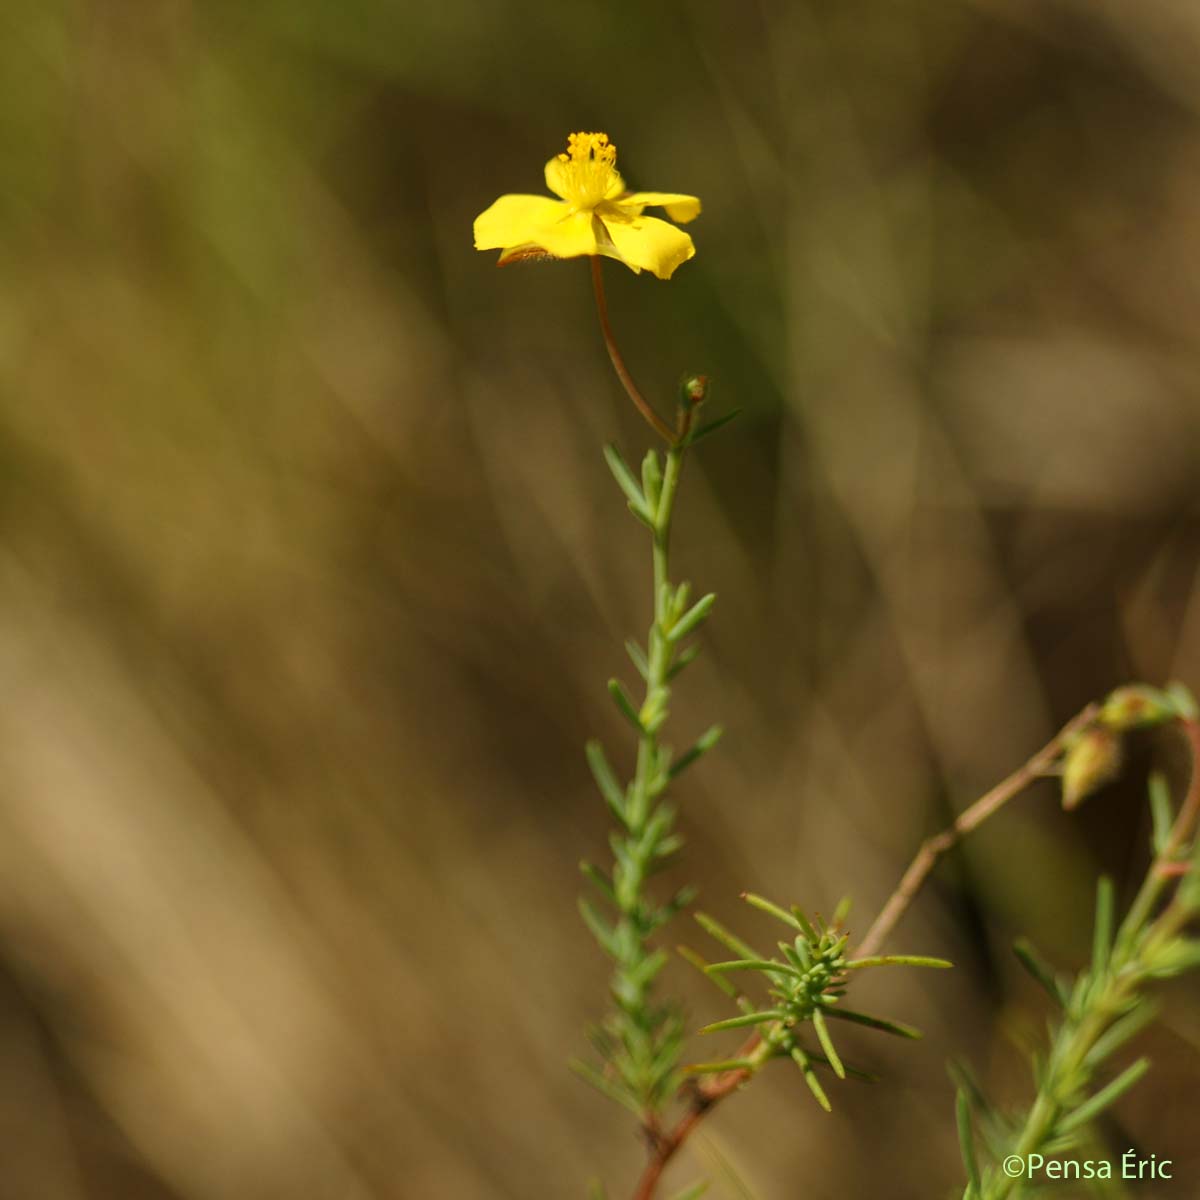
left=0, top=0, right=1200, bottom=1200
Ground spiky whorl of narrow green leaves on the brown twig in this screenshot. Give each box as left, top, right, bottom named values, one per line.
left=680, top=893, right=950, bottom=1112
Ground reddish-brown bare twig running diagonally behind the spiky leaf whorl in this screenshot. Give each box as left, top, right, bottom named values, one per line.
left=632, top=703, right=1099, bottom=1200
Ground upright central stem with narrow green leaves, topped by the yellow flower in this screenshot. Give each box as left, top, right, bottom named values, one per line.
left=475, top=133, right=725, bottom=1135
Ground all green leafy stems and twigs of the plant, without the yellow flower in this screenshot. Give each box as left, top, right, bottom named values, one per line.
left=574, top=284, right=1200, bottom=1200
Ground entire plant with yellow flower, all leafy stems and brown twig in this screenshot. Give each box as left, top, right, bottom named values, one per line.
left=475, top=133, right=1200, bottom=1200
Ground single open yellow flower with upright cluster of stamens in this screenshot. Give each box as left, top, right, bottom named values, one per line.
left=475, top=133, right=700, bottom=280
